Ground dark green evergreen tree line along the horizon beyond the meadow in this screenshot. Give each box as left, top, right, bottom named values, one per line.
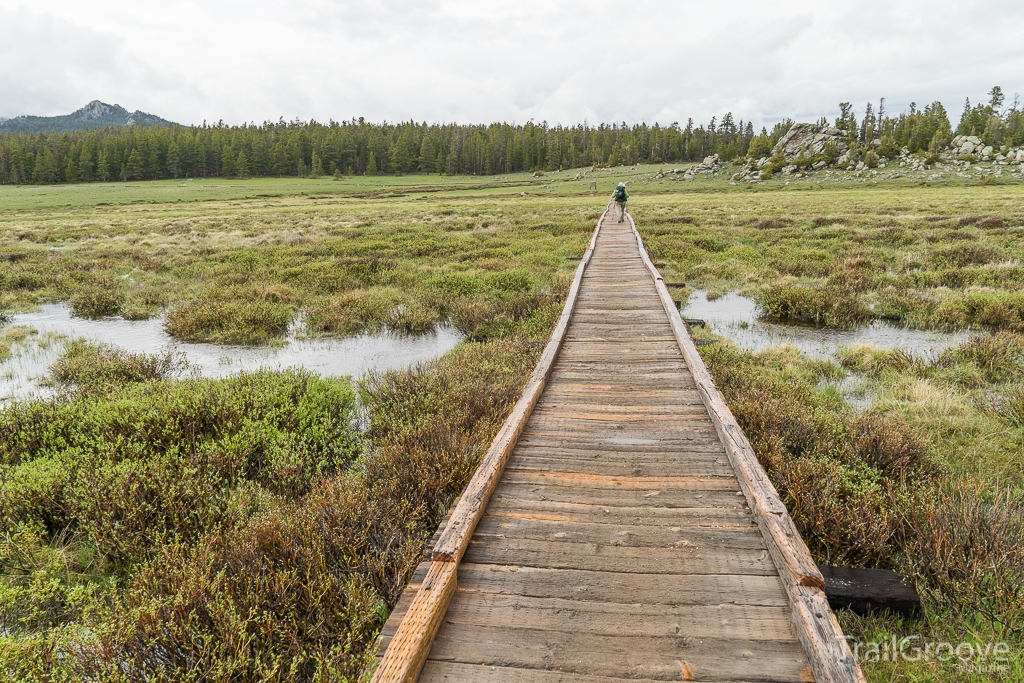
left=0, top=87, right=1024, bottom=184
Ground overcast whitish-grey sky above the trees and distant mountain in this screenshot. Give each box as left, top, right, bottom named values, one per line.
left=0, top=0, right=1024, bottom=125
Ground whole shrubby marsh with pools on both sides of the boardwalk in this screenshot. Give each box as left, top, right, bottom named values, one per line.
left=0, top=167, right=1024, bottom=681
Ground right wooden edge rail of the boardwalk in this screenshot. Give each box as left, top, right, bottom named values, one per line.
left=627, top=215, right=865, bottom=683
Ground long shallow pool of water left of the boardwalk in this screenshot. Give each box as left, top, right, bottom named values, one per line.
left=0, top=304, right=463, bottom=402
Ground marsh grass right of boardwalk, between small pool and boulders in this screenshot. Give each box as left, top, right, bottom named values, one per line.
left=634, top=187, right=1024, bottom=330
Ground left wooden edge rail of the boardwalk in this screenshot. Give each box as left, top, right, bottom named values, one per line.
left=371, top=205, right=610, bottom=683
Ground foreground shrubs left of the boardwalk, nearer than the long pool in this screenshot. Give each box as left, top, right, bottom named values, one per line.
left=0, top=341, right=540, bottom=681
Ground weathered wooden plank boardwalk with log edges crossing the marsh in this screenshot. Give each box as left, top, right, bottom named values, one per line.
left=374, top=210, right=863, bottom=683
